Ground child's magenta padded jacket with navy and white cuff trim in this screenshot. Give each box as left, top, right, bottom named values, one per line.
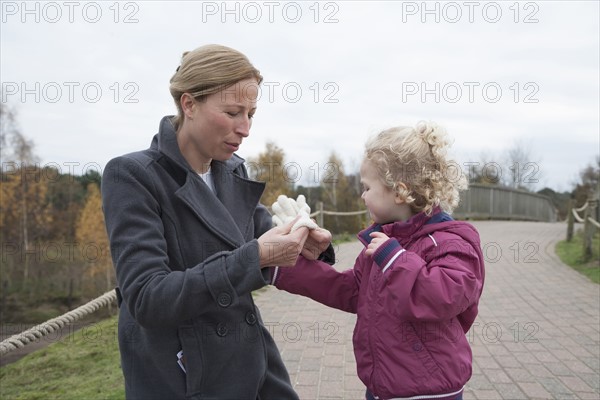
left=274, top=210, right=484, bottom=399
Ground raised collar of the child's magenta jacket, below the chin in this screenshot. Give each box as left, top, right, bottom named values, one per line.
left=358, top=207, right=453, bottom=245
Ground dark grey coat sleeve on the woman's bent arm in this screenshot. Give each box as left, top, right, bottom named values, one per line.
left=102, top=157, right=267, bottom=328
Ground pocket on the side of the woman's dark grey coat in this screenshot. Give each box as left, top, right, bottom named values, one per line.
left=174, top=326, right=204, bottom=397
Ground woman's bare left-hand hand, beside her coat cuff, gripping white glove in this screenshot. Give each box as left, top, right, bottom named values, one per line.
left=258, top=218, right=308, bottom=268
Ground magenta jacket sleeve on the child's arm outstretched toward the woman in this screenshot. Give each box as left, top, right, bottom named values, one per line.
left=273, top=256, right=362, bottom=314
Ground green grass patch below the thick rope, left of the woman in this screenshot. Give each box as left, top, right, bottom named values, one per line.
left=0, top=317, right=125, bottom=400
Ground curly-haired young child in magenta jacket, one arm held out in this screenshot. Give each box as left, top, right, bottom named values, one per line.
left=274, top=122, right=484, bottom=400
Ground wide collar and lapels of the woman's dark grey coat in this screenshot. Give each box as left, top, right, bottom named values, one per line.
left=151, top=116, right=265, bottom=247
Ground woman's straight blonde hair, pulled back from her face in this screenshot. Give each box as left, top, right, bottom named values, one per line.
left=169, top=44, right=263, bottom=129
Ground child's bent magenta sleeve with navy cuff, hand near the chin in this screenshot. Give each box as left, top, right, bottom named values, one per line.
left=373, top=236, right=483, bottom=321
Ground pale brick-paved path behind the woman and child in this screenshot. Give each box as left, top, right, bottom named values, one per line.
left=256, top=221, right=600, bottom=400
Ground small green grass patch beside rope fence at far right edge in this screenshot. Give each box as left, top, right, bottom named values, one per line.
left=555, top=231, right=600, bottom=284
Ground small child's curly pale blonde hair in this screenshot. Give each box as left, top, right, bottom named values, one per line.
left=365, top=121, right=468, bottom=214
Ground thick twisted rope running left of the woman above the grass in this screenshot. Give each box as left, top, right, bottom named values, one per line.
left=0, top=290, right=117, bottom=356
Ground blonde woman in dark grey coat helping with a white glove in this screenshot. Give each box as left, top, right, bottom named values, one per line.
left=102, top=45, right=327, bottom=400
